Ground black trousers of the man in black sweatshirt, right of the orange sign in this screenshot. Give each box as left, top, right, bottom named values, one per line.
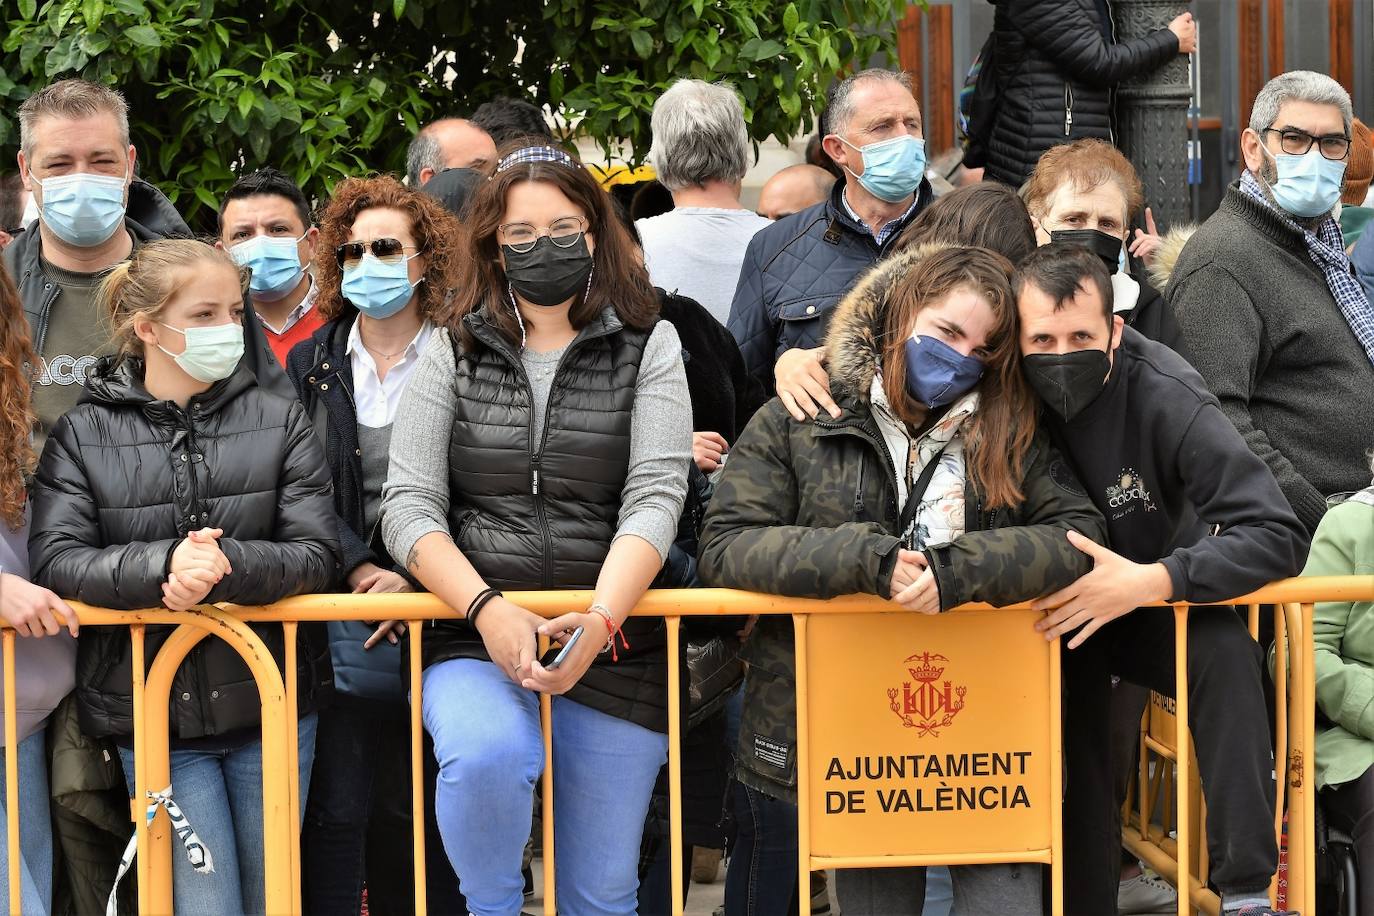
left=1062, top=607, right=1278, bottom=916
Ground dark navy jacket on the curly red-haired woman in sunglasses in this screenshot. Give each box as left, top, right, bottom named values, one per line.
left=286, top=310, right=405, bottom=700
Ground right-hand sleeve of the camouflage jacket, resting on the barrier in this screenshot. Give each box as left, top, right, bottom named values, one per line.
left=925, top=438, right=1107, bottom=611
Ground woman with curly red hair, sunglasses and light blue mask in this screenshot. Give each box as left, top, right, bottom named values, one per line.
left=286, top=176, right=463, bottom=916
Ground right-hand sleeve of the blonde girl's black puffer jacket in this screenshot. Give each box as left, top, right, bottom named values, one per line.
left=206, top=401, right=339, bottom=604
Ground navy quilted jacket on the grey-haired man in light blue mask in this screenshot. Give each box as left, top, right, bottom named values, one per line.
left=730, top=179, right=934, bottom=393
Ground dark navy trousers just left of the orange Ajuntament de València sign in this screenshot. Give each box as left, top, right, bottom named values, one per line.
left=725, top=783, right=811, bottom=916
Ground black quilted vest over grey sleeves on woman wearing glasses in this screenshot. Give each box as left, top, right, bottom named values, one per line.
left=406, top=309, right=681, bottom=732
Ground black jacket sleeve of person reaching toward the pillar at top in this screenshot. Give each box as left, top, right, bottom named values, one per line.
left=1007, top=0, right=1179, bottom=89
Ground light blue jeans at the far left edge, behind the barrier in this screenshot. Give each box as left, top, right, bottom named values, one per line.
left=0, top=729, right=52, bottom=916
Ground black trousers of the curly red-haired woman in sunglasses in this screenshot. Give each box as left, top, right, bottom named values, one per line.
left=301, top=694, right=467, bottom=916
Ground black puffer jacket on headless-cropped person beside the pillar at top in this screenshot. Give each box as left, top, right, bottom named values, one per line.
left=987, top=0, right=1179, bottom=187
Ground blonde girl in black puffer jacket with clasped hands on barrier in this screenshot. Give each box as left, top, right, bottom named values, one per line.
left=29, top=240, right=338, bottom=915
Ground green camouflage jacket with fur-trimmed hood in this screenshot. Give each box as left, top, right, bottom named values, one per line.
left=699, top=243, right=1106, bottom=801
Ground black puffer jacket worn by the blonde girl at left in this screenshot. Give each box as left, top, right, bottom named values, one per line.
left=29, top=357, right=338, bottom=739
